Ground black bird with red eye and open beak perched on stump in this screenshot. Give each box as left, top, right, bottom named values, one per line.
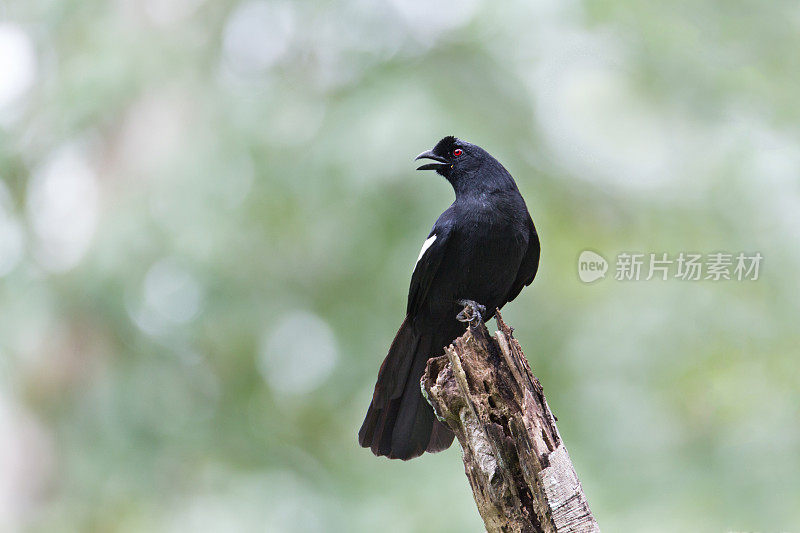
left=358, top=136, right=539, bottom=460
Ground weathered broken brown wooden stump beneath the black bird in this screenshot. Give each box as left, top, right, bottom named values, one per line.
left=422, top=311, right=600, bottom=533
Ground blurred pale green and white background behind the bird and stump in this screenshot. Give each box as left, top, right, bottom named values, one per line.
left=0, top=0, right=800, bottom=533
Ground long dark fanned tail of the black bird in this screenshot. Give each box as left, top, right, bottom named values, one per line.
left=358, top=317, right=455, bottom=460
